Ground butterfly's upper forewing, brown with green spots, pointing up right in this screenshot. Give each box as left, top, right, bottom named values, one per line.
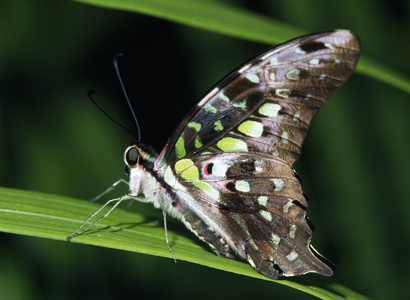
left=159, top=30, right=360, bottom=165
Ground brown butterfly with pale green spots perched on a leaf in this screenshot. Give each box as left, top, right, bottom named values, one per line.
left=69, top=30, right=360, bottom=279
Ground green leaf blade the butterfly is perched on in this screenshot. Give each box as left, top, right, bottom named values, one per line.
left=0, top=188, right=366, bottom=299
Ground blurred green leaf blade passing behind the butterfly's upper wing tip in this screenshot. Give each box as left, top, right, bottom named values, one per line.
left=76, top=0, right=410, bottom=94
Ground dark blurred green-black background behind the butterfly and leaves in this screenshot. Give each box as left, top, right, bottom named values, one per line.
left=0, top=0, right=410, bottom=299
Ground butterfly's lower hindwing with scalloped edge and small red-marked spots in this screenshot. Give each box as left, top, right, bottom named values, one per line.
left=173, top=153, right=332, bottom=279
